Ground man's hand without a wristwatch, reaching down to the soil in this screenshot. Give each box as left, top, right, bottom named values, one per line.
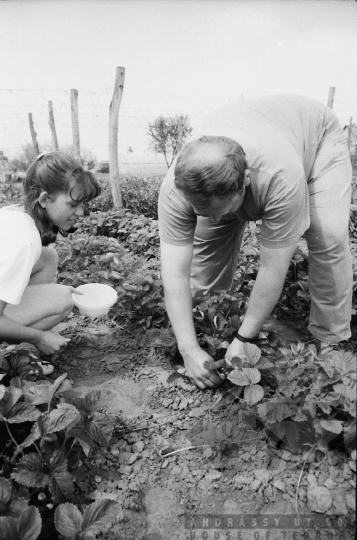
left=182, top=348, right=225, bottom=390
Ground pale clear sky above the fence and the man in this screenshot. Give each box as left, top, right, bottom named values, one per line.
left=0, top=0, right=357, bottom=159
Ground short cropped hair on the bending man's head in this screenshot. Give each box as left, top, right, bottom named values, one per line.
left=175, top=135, right=248, bottom=200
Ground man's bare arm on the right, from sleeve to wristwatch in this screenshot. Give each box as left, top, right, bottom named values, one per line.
left=239, top=243, right=296, bottom=338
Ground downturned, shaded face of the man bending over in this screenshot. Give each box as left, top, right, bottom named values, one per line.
left=188, top=188, right=245, bottom=223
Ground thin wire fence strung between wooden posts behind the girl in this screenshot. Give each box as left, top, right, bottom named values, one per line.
left=0, top=86, right=228, bottom=169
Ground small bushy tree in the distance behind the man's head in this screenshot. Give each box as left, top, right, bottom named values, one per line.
left=148, top=114, right=192, bottom=167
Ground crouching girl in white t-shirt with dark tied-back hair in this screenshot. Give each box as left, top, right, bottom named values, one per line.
left=0, top=152, right=100, bottom=370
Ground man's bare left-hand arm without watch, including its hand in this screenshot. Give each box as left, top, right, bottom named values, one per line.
left=161, top=242, right=222, bottom=389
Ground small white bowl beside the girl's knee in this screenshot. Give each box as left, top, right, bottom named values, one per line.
left=72, top=283, right=118, bottom=319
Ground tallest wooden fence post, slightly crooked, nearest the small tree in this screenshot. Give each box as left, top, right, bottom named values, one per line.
left=109, top=63, right=125, bottom=208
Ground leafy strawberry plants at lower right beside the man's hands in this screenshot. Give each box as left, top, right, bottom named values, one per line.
left=206, top=343, right=356, bottom=452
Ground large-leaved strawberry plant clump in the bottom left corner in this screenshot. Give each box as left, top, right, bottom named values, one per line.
left=0, top=345, right=117, bottom=540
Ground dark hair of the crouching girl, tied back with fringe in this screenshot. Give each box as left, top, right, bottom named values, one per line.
left=23, top=152, right=100, bottom=246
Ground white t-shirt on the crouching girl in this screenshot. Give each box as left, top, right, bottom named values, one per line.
left=0, top=206, right=42, bottom=304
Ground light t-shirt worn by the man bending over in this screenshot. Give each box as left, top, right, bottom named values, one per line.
left=158, top=95, right=336, bottom=248
